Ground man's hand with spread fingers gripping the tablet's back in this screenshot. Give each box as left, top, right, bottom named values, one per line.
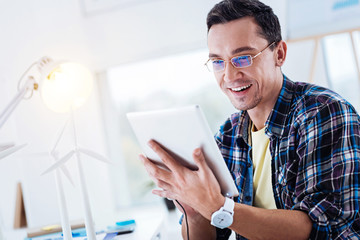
left=140, top=140, right=225, bottom=219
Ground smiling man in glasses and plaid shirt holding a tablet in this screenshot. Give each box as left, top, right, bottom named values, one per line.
left=140, top=0, right=360, bottom=240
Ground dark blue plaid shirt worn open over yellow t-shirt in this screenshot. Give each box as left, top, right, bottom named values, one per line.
left=215, top=76, right=360, bottom=239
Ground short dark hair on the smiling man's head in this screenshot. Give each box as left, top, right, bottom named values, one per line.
left=206, top=0, right=282, bottom=49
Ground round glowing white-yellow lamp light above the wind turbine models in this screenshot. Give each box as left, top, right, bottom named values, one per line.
left=40, top=62, right=93, bottom=112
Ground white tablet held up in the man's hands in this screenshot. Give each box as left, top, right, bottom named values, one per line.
left=127, top=105, right=239, bottom=197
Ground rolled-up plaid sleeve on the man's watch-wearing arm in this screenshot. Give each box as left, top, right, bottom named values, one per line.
left=293, top=102, right=360, bottom=239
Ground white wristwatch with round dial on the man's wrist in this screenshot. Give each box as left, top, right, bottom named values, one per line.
left=211, top=197, right=235, bottom=229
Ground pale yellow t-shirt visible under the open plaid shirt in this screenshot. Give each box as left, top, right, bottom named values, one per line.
left=251, top=128, right=276, bottom=209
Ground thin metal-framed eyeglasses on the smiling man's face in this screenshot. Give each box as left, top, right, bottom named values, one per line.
left=205, top=42, right=275, bottom=72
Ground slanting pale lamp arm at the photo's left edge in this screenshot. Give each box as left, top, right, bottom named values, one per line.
left=0, top=76, right=35, bottom=128
